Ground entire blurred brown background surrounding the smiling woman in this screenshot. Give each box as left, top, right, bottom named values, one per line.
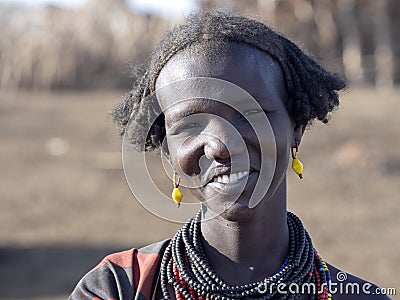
left=0, top=0, right=400, bottom=299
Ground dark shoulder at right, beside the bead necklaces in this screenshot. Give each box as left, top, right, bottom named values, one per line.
left=327, top=263, right=390, bottom=300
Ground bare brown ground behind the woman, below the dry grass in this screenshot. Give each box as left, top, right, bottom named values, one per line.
left=0, top=89, right=400, bottom=299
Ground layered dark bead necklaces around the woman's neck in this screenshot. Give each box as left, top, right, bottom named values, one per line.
left=160, top=211, right=332, bottom=300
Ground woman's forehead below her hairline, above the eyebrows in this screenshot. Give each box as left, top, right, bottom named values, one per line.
left=156, top=42, right=287, bottom=113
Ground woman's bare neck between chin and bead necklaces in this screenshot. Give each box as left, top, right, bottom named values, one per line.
left=201, top=180, right=289, bottom=284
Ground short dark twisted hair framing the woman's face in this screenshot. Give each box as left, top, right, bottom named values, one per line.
left=111, top=10, right=346, bottom=151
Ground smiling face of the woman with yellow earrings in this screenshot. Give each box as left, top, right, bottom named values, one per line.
left=156, top=43, right=301, bottom=221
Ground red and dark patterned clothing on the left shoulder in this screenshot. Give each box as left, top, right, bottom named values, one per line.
left=68, top=240, right=169, bottom=300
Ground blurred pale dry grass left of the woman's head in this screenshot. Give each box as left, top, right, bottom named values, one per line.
left=0, top=0, right=168, bottom=90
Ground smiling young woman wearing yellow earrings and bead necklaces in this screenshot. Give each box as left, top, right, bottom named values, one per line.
left=70, top=11, right=388, bottom=299
